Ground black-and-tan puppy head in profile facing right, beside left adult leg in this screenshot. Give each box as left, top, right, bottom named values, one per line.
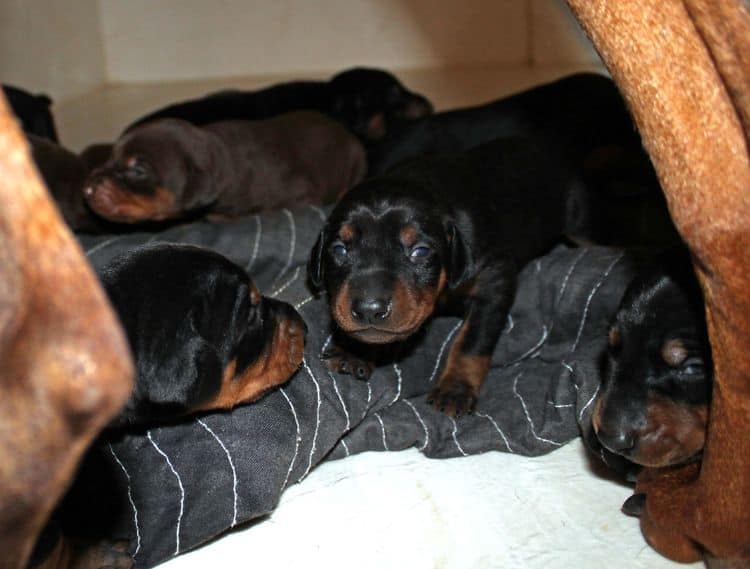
left=102, top=244, right=305, bottom=424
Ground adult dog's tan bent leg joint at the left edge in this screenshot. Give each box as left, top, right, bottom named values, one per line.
left=0, top=93, right=133, bottom=568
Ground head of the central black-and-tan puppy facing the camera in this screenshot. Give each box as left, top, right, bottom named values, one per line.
left=308, top=178, right=470, bottom=344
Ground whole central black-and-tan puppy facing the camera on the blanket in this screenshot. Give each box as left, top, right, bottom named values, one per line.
left=309, top=138, right=571, bottom=415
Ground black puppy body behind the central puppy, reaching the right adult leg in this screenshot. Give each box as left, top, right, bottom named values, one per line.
left=367, top=73, right=679, bottom=246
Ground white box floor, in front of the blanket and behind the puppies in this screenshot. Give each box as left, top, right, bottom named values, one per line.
left=54, top=68, right=704, bottom=569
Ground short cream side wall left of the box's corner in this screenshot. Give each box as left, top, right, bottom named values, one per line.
left=0, top=0, right=106, bottom=101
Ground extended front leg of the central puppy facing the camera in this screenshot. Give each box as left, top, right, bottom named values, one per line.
left=427, top=263, right=516, bottom=417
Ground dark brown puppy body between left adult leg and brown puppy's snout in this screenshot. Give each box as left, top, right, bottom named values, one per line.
left=27, top=134, right=106, bottom=233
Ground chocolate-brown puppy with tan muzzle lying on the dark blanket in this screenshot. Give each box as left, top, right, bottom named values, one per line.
left=84, top=111, right=366, bottom=223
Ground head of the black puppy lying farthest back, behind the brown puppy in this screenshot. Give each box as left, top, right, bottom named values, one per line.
left=330, top=67, right=433, bottom=140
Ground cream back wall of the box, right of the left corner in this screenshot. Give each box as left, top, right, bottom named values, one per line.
left=99, top=0, right=596, bottom=82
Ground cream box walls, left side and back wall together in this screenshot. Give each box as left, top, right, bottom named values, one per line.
left=0, top=0, right=598, bottom=98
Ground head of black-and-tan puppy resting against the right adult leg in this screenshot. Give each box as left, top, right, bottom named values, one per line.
left=592, top=253, right=712, bottom=467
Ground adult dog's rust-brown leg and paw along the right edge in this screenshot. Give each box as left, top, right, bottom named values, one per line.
left=568, top=0, right=750, bottom=564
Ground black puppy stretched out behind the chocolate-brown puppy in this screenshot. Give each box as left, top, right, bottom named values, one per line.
left=125, top=67, right=432, bottom=142
